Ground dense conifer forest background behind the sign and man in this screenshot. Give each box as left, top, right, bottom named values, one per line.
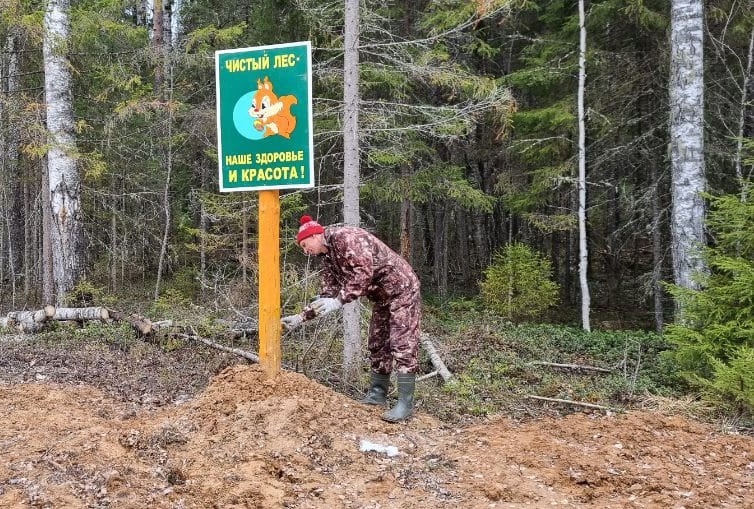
left=0, top=0, right=754, bottom=418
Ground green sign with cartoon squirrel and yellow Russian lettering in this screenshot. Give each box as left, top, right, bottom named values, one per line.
left=215, top=41, right=314, bottom=191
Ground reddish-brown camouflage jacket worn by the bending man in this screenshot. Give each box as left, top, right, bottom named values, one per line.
left=320, top=226, right=419, bottom=304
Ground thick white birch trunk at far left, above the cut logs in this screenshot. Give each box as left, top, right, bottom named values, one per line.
left=42, top=0, right=84, bottom=305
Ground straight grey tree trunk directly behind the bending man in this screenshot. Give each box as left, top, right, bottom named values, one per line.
left=343, top=0, right=362, bottom=382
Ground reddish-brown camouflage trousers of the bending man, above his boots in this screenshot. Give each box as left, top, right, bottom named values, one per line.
left=368, top=289, right=421, bottom=374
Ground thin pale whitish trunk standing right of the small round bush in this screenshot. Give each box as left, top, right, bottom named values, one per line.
left=578, top=0, right=591, bottom=331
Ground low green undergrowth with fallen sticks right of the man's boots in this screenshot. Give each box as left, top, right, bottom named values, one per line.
left=420, top=304, right=680, bottom=421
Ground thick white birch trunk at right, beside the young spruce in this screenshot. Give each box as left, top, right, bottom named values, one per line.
left=669, top=0, right=706, bottom=298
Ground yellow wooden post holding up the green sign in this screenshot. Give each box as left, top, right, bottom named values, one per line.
left=259, top=190, right=280, bottom=377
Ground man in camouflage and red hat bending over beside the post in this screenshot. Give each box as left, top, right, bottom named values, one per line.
left=281, top=216, right=421, bottom=422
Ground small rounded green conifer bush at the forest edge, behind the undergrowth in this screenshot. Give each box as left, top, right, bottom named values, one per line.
left=480, top=243, right=559, bottom=321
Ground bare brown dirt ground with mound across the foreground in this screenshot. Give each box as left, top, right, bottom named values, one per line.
left=0, top=338, right=754, bottom=509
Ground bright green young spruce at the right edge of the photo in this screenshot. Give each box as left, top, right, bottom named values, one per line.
left=667, top=184, right=754, bottom=413
